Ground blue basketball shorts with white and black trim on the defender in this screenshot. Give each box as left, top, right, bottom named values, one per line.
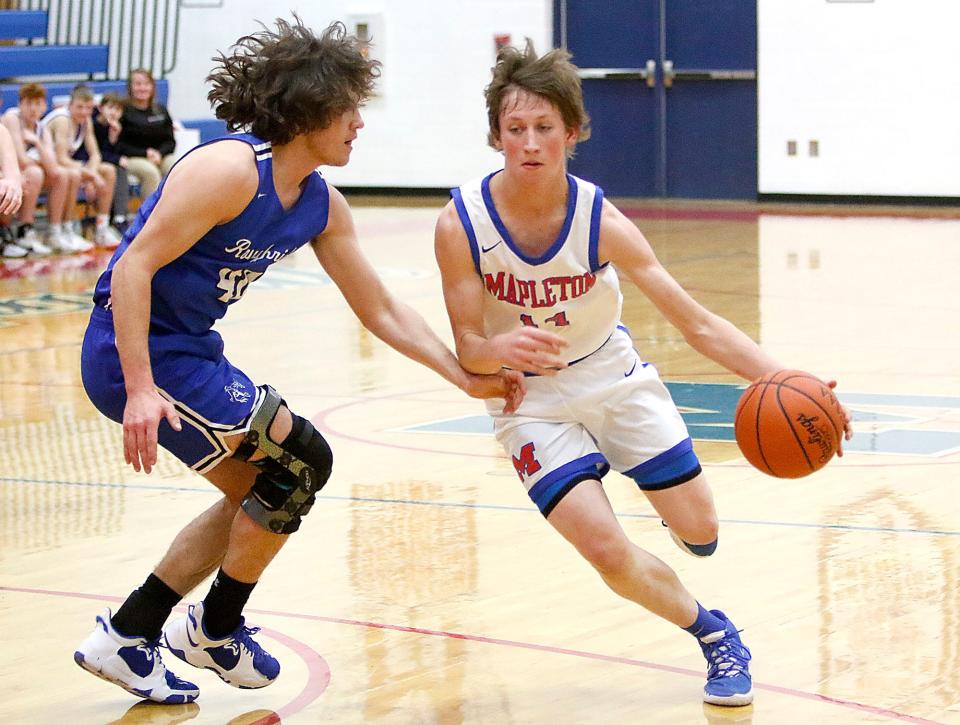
left=80, top=308, right=262, bottom=473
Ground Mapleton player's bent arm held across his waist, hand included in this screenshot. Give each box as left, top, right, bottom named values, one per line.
left=434, top=202, right=567, bottom=375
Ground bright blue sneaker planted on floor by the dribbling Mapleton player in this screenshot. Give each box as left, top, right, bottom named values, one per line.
left=700, top=609, right=753, bottom=707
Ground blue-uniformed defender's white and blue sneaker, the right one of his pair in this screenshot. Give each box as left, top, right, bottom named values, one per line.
left=163, top=602, right=280, bottom=689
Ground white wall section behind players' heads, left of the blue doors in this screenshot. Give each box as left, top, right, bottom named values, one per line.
left=169, top=0, right=551, bottom=188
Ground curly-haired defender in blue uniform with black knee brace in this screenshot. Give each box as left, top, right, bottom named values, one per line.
left=74, top=19, right=523, bottom=703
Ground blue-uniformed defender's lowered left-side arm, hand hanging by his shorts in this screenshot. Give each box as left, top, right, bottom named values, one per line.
left=111, top=141, right=258, bottom=473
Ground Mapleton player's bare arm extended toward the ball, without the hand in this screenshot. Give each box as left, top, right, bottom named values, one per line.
left=599, top=201, right=784, bottom=380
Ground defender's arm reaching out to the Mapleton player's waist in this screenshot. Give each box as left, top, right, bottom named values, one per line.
left=313, top=187, right=524, bottom=412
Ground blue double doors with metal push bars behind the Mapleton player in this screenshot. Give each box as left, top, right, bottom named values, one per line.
left=554, top=0, right=757, bottom=199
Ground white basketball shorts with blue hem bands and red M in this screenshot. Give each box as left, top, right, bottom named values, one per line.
left=488, top=327, right=701, bottom=516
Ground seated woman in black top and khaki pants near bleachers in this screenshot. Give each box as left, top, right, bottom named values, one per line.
left=117, top=68, right=177, bottom=199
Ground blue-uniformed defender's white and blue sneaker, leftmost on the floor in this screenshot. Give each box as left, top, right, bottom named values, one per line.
left=73, top=609, right=200, bottom=705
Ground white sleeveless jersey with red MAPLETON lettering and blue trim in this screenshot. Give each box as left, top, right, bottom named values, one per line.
left=452, top=172, right=623, bottom=363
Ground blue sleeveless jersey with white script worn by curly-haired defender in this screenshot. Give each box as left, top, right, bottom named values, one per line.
left=93, top=134, right=330, bottom=335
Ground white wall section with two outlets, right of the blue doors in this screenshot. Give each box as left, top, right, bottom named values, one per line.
left=758, top=0, right=960, bottom=196
